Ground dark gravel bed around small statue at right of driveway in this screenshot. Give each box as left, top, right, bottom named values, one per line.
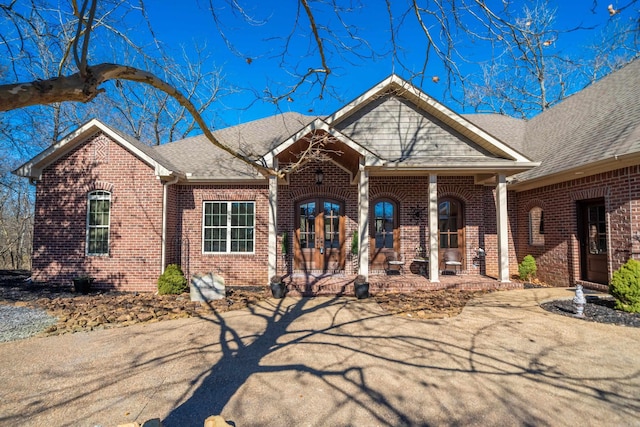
left=541, top=295, right=640, bottom=328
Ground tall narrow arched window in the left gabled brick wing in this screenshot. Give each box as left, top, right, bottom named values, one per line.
left=87, top=191, right=111, bottom=255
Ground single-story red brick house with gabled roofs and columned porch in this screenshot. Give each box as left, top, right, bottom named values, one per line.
left=15, top=60, right=640, bottom=293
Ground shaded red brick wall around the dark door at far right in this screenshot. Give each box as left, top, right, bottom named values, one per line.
left=517, top=166, right=640, bottom=286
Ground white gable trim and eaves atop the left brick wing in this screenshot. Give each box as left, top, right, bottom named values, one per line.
left=14, top=119, right=175, bottom=179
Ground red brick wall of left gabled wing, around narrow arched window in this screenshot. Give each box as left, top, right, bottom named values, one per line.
left=33, top=134, right=162, bottom=291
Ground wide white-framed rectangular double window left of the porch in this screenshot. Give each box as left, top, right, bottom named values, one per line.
left=202, top=202, right=255, bottom=253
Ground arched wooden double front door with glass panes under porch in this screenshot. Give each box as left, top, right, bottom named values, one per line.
left=294, top=198, right=345, bottom=272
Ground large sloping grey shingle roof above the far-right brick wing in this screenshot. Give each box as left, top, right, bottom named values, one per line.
left=517, top=59, right=640, bottom=181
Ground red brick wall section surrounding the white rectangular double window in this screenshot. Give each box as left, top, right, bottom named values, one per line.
left=172, top=183, right=269, bottom=286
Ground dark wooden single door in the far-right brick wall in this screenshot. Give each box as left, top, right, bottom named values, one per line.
left=580, top=200, right=609, bottom=284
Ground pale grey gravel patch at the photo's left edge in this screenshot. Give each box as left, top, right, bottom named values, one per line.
left=0, top=305, right=58, bottom=342
